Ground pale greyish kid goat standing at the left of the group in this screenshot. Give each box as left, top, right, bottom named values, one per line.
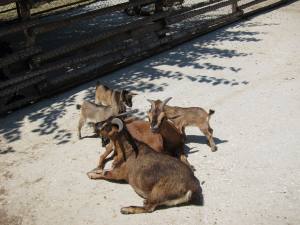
left=77, top=93, right=124, bottom=139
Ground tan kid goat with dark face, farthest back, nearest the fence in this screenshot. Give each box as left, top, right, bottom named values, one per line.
left=95, top=82, right=137, bottom=111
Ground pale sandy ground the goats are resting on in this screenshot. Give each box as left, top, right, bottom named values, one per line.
left=0, top=1, right=300, bottom=225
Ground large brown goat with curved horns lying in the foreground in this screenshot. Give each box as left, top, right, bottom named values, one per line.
left=88, top=118, right=202, bottom=214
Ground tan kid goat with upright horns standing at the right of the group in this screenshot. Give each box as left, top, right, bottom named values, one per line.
left=148, top=98, right=217, bottom=152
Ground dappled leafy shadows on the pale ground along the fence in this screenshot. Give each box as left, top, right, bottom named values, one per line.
left=0, top=19, right=276, bottom=147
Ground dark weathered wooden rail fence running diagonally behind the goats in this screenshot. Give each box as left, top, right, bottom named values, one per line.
left=0, top=0, right=287, bottom=113
